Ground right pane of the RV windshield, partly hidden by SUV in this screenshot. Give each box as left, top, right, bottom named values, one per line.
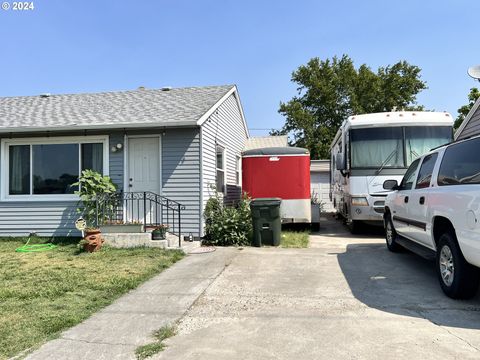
left=405, top=126, right=452, bottom=166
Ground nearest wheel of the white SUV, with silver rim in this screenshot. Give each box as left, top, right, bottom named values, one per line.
left=436, top=232, right=479, bottom=299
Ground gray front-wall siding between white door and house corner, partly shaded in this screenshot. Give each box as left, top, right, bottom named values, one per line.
left=162, top=128, right=200, bottom=236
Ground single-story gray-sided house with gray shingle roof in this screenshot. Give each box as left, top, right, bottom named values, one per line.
left=0, top=85, right=249, bottom=236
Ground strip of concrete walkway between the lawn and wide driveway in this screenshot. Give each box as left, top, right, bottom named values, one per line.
left=27, top=248, right=238, bottom=360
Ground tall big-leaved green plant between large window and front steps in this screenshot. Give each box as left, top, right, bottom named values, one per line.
left=72, top=169, right=117, bottom=226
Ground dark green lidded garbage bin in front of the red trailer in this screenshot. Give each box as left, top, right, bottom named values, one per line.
left=250, top=198, right=282, bottom=246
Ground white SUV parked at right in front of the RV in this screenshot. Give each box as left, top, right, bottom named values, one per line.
left=383, top=137, right=480, bottom=298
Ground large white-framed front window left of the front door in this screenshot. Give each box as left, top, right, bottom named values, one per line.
left=4, top=139, right=107, bottom=197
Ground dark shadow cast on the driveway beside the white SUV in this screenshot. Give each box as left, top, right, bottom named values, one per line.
left=338, top=243, right=480, bottom=329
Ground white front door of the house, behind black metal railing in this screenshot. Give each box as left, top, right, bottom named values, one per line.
left=124, top=137, right=161, bottom=225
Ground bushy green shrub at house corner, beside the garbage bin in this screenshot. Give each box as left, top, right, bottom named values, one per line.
left=204, top=196, right=253, bottom=246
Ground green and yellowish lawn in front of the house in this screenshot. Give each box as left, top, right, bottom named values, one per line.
left=0, top=239, right=183, bottom=359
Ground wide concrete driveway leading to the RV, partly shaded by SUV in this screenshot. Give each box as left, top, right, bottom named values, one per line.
left=155, top=215, right=480, bottom=359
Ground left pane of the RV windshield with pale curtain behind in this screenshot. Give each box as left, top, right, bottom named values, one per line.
left=350, top=127, right=405, bottom=168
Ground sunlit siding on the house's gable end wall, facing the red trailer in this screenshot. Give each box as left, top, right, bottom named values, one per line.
left=202, top=93, right=247, bottom=235
